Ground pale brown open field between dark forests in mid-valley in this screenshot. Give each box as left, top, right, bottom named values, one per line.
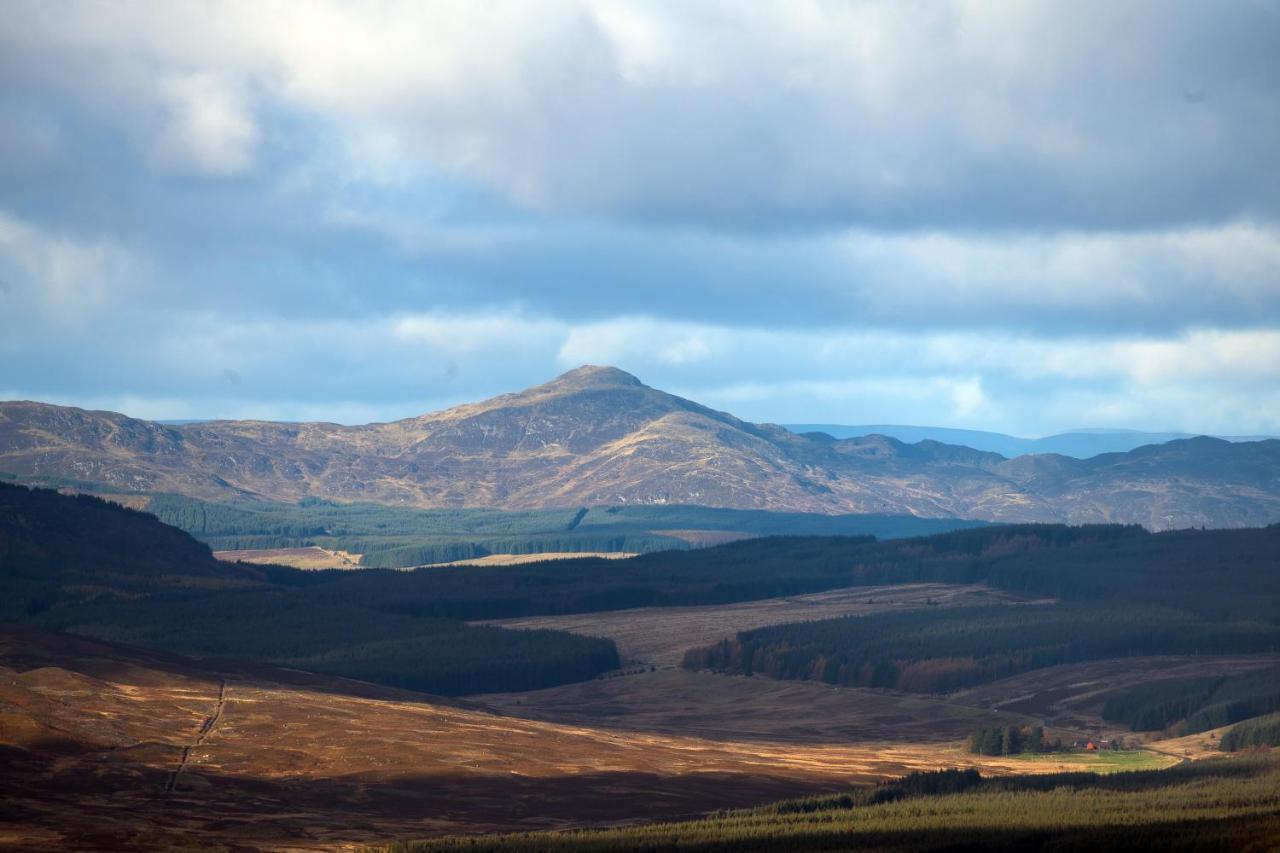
left=485, top=584, right=1046, bottom=667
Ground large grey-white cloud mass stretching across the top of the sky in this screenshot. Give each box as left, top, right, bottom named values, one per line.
left=0, top=0, right=1280, bottom=225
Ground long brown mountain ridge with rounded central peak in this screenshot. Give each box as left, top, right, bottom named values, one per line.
left=0, top=366, right=1280, bottom=529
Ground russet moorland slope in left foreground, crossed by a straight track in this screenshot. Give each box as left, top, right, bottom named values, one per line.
left=0, top=628, right=1162, bottom=849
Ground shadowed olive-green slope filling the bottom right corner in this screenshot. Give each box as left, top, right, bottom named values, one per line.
left=392, top=754, right=1280, bottom=853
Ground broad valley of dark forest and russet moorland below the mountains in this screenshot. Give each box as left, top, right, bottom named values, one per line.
left=0, top=484, right=1280, bottom=850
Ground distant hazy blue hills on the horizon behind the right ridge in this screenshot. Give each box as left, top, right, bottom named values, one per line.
left=783, top=424, right=1271, bottom=459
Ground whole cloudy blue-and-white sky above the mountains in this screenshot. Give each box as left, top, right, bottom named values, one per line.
left=0, top=0, right=1280, bottom=435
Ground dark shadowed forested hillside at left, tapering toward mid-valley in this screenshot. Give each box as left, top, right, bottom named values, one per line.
left=0, top=483, right=618, bottom=694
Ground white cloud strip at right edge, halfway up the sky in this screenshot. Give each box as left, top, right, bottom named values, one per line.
left=838, top=222, right=1280, bottom=328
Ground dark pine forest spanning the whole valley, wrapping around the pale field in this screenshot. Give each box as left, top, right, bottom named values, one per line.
left=0, top=484, right=1280, bottom=707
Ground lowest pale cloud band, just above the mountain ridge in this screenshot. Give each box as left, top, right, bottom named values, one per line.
left=0, top=292, right=1280, bottom=434
